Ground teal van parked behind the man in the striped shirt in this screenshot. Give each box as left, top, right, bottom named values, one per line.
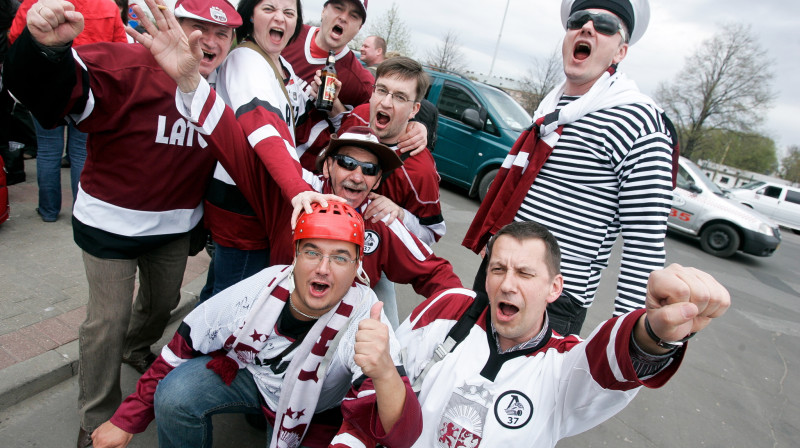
left=426, top=67, right=531, bottom=200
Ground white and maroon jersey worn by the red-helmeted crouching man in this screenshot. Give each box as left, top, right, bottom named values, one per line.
left=111, top=266, right=421, bottom=448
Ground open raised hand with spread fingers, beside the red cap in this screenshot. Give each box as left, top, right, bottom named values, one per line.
left=125, top=0, right=203, bottom=93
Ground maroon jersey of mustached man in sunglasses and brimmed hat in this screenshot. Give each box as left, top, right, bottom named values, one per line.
left=177, top=85, right=461, bottom=297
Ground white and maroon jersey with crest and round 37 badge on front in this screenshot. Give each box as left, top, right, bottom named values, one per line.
left=396, top=289, right=684, bottom=448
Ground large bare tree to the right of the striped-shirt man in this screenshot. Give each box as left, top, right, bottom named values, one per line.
left=656, top=24, right=775, bottom=157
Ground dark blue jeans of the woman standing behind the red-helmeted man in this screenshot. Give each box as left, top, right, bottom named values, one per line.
left=197, top=241, right=269, bottom=305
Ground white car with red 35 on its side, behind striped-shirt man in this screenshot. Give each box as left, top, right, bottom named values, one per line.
left=667, top=157, right=781, bottom=257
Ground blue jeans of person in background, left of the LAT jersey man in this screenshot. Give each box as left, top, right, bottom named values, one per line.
left=34, top=120, right=86, bottom=221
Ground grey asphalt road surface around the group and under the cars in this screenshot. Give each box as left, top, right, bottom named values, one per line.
left=0, top=187, right=800, bottom=448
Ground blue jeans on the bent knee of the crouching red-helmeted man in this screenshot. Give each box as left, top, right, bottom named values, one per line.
left=153, top=356, right=262, bottom=448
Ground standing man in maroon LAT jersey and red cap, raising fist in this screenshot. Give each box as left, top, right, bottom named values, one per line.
left=3, top=0, right=241, bottom=447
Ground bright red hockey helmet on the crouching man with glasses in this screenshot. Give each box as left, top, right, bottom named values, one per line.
left=293, top=201, right=364, bottom=258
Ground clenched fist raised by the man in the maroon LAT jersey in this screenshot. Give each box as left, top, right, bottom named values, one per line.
left=26, top=0, right=83, bottom=47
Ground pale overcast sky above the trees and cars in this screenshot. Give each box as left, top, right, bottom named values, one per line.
left=303, top=0, right=800, bottom=157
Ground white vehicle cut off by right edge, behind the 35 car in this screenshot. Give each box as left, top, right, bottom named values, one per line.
left=730, top=181, right=800, bottom=234
